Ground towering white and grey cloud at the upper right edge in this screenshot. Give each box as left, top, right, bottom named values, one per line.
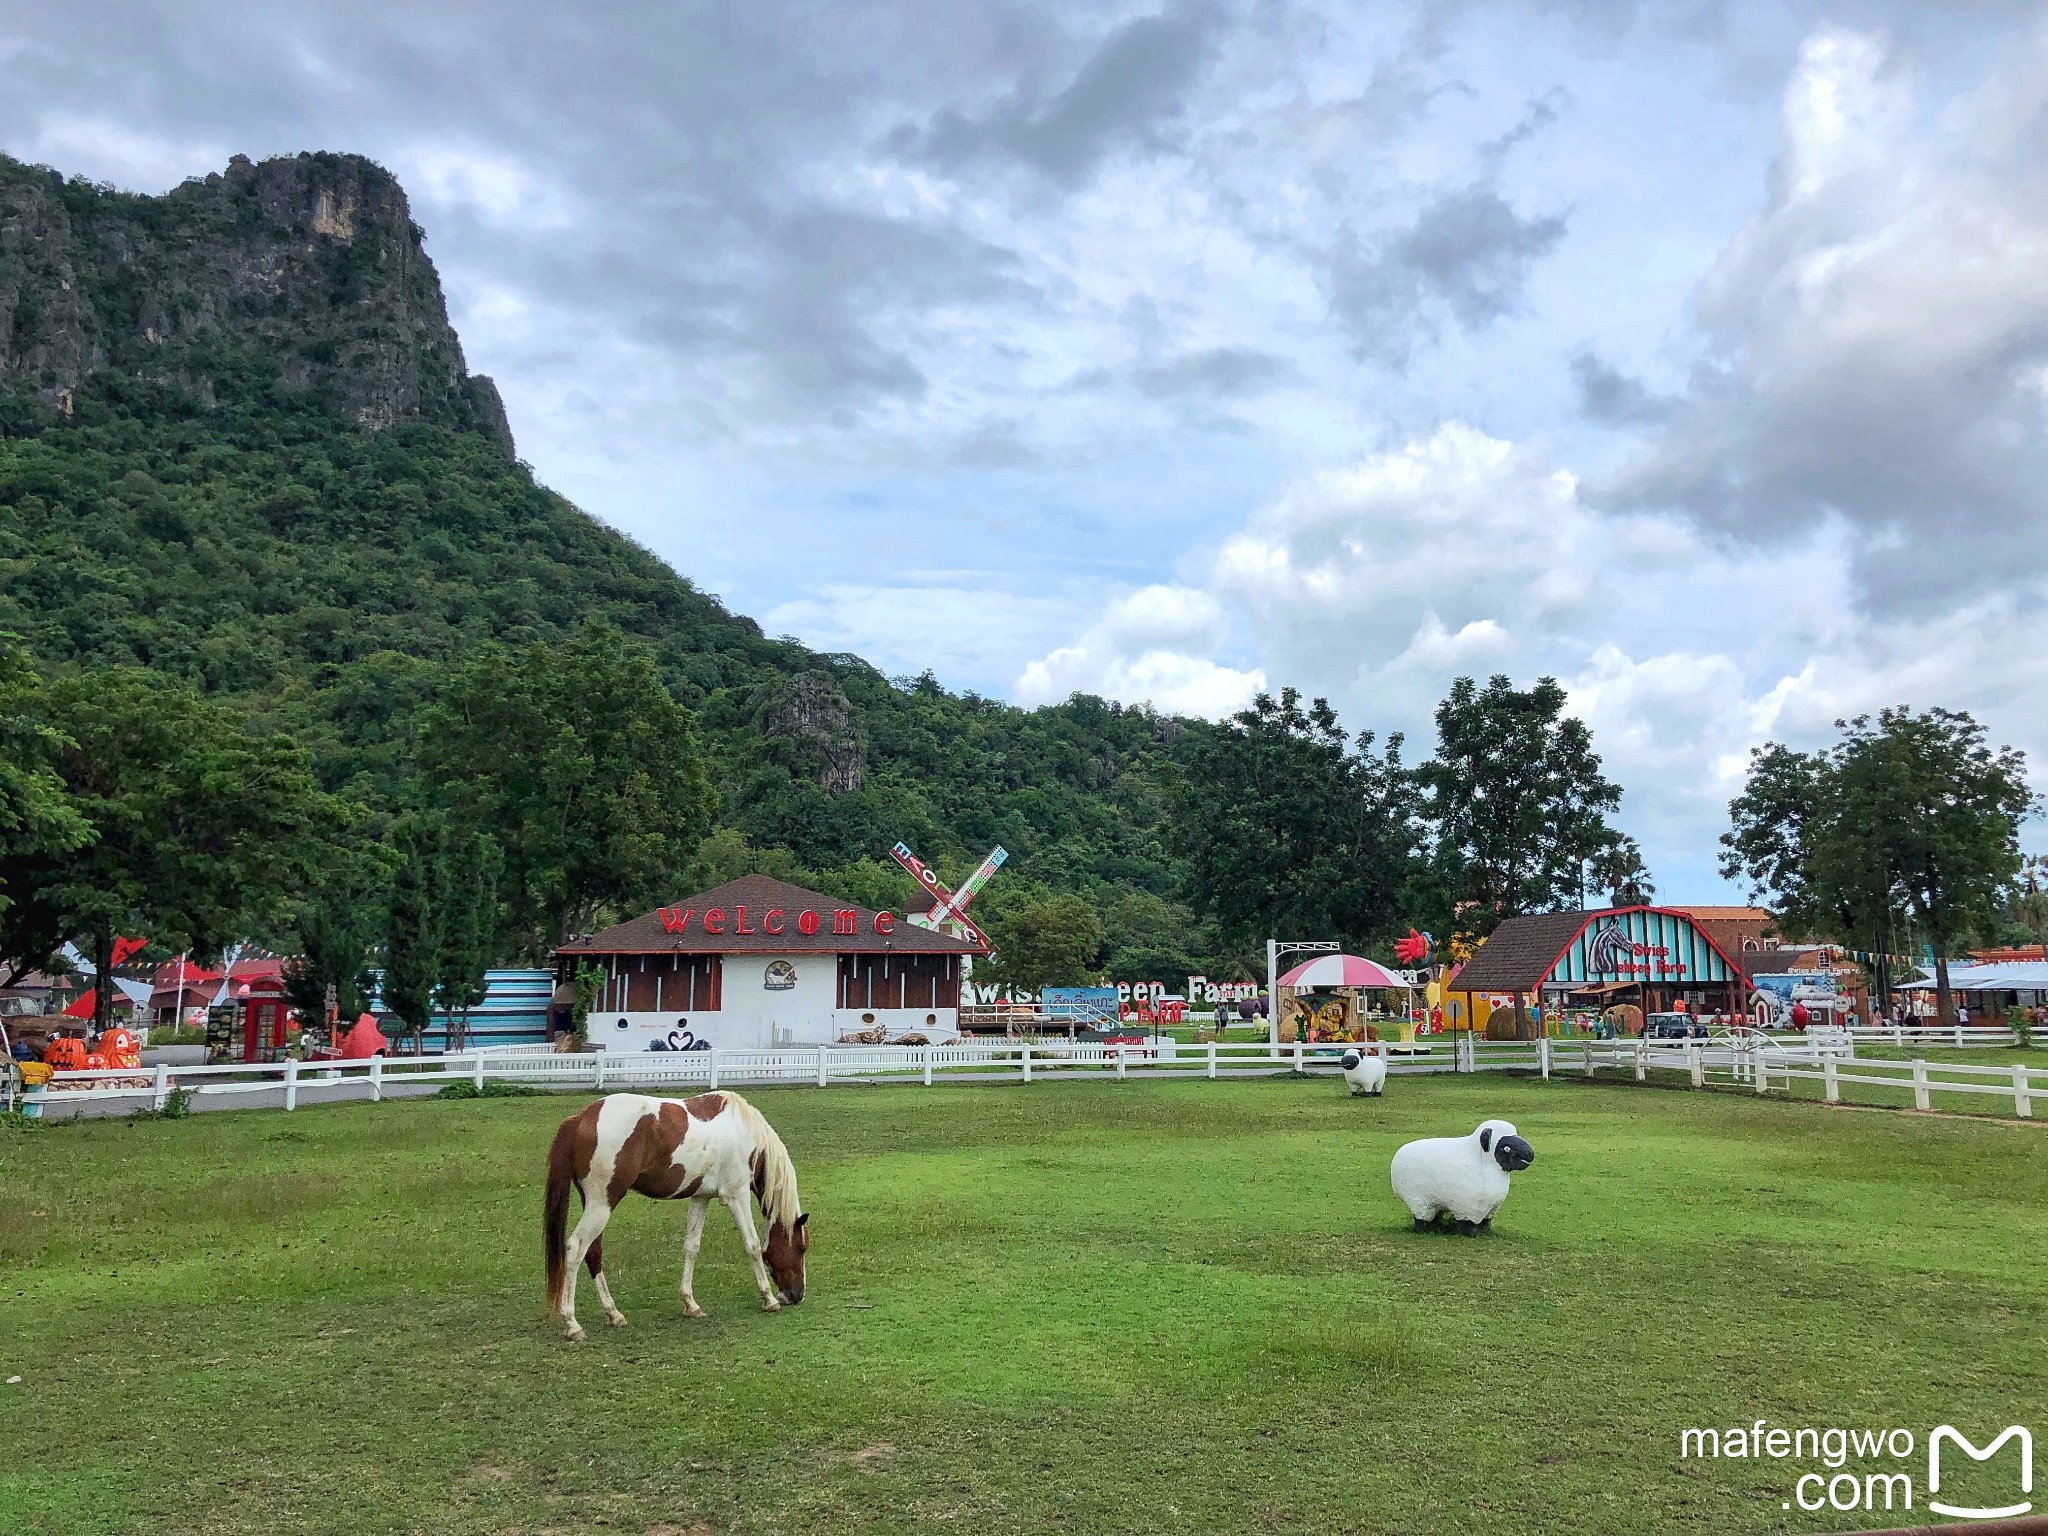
left=1597, top=27, right=2048, bottom=612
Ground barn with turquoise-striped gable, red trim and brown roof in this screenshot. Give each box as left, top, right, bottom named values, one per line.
left=1444, top=907, right=1751, bottom=1032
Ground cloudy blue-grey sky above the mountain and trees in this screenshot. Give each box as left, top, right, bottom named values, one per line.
left=0, top=0, right=2048, bottom=899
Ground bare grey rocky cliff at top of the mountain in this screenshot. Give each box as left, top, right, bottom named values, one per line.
left=0, top=154, right=512, bottom=453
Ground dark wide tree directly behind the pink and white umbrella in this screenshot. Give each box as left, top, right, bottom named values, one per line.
left=1171, top=688, right=1415, bottom=944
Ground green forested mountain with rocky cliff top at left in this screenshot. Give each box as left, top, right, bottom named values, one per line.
left=0, top=156, right=1204, bottom=975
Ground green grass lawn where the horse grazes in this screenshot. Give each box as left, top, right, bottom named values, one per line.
left=0, top=1077, right=2048, bottom=1536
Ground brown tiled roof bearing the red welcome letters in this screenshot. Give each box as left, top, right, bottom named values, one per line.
left=555, top=874, right=981, bottom=958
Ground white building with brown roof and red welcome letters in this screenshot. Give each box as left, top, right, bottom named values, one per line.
left=555, top=874, right=981, bottom=1053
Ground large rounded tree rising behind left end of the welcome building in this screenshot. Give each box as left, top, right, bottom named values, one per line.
left=422, top=623, right=713, bottom=956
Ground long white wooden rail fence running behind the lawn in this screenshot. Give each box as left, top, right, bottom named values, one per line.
left=27, top=1028, right=2048, bottom=1116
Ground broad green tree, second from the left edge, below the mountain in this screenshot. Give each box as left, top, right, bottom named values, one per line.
left=31, top=668, right=342, bottom=1030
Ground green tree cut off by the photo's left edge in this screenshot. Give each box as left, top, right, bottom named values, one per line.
left=0, top=633, right=92, bottom=985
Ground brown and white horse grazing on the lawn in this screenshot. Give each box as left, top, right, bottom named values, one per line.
left=541, top=1094, right=811, bottom=1339
